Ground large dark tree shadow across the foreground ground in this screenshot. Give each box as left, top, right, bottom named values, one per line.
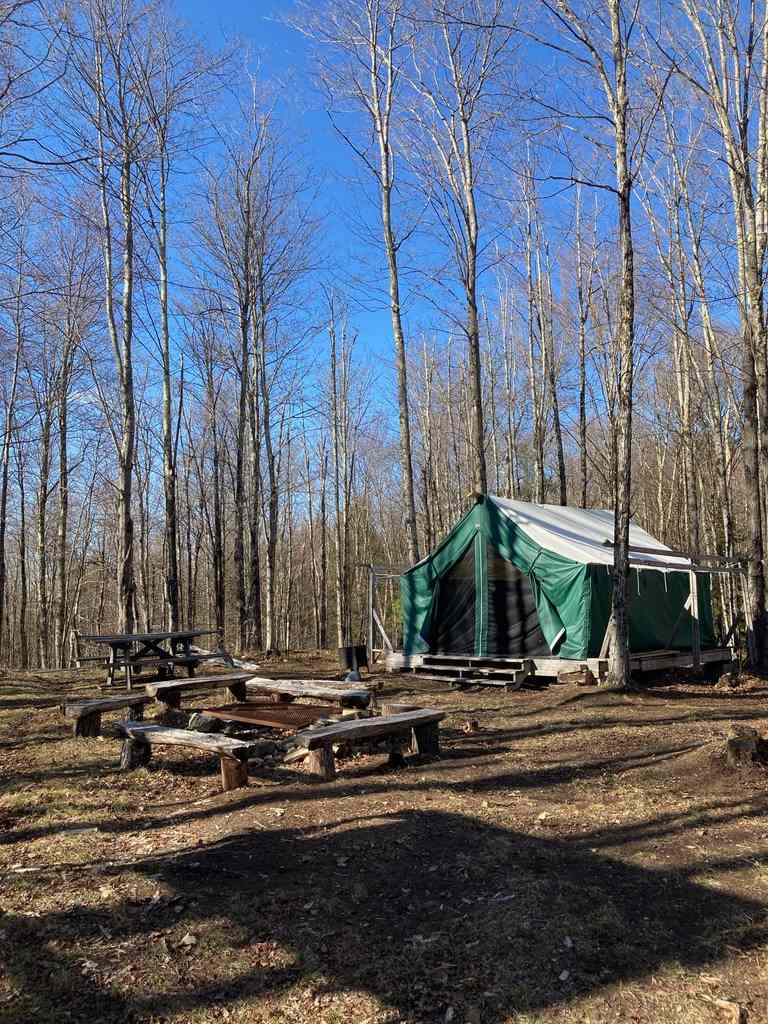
left=2, top=810, right=766, bottom=1024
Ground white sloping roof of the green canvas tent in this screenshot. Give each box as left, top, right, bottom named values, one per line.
left=487, top=495, right=690, bottom=569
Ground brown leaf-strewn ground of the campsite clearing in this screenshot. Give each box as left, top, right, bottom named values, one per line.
left=0, top=657, right=768, bottom=1024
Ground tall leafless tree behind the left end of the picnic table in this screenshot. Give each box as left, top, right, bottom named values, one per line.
left=62, top=0, right=159, bottom=632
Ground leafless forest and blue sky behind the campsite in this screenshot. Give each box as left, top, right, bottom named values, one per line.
left=0, top=0, right=768, bottom=673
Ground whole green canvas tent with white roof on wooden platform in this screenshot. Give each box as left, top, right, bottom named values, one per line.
left=400, top=496, right=715, bottom=659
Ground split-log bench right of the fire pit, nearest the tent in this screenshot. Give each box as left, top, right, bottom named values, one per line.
left=292, top=708, right=445, bottom=782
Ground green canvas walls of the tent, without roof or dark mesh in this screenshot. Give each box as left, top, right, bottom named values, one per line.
left=400, top=500, right=715, bottom=658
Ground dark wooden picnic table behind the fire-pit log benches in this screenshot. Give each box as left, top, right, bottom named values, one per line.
left=75, top=629, right=231, bottom=690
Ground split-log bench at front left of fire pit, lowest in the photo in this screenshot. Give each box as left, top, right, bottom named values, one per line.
left=118, top=722, right=251, bottom=793
